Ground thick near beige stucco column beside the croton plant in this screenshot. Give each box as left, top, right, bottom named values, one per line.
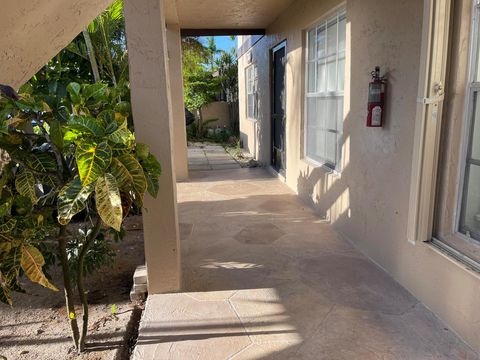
left=124, top=0, right=181, bottom=294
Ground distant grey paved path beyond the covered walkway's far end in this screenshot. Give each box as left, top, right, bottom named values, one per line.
left=188, top=145, right=240, bottom=171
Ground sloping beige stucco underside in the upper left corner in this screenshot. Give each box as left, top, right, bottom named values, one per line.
left=0, top=0, right=112, bottom=88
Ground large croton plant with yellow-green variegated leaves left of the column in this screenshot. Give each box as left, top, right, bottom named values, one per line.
left=0, top=83, right=160, bottom=351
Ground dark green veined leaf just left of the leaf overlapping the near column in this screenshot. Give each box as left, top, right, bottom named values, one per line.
left=111, top=155, right=147, bottom=196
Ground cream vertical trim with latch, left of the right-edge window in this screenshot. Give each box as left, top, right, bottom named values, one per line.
left=407, top=0, right=451, bottom=244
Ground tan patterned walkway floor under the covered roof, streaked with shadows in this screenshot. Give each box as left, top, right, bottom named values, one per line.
left=134, top=168, right=478, bottom=360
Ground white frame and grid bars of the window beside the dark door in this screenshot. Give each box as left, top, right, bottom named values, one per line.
left=303, top=5, right=347, bottom=173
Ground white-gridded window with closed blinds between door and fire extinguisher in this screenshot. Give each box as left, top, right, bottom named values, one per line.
left=305, top=10, right=346, bottom=170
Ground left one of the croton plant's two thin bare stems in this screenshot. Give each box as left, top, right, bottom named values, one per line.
left=58, top=226, right=80, bottom=351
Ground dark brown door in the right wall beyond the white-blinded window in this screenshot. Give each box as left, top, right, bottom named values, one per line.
left=271, top=41, right=286, bottom=176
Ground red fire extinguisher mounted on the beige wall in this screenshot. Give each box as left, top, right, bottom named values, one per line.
left=367, top=66, right=387, bottom=127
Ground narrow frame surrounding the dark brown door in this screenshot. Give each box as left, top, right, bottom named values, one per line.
left=269, top=39, right=287, bottom=180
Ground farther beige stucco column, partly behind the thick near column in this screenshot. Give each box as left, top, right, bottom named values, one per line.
left=167, top=24, right=188, bottom=180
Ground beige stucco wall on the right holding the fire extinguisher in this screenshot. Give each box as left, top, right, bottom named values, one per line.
left=239, top=0, right=480, bottom=350
